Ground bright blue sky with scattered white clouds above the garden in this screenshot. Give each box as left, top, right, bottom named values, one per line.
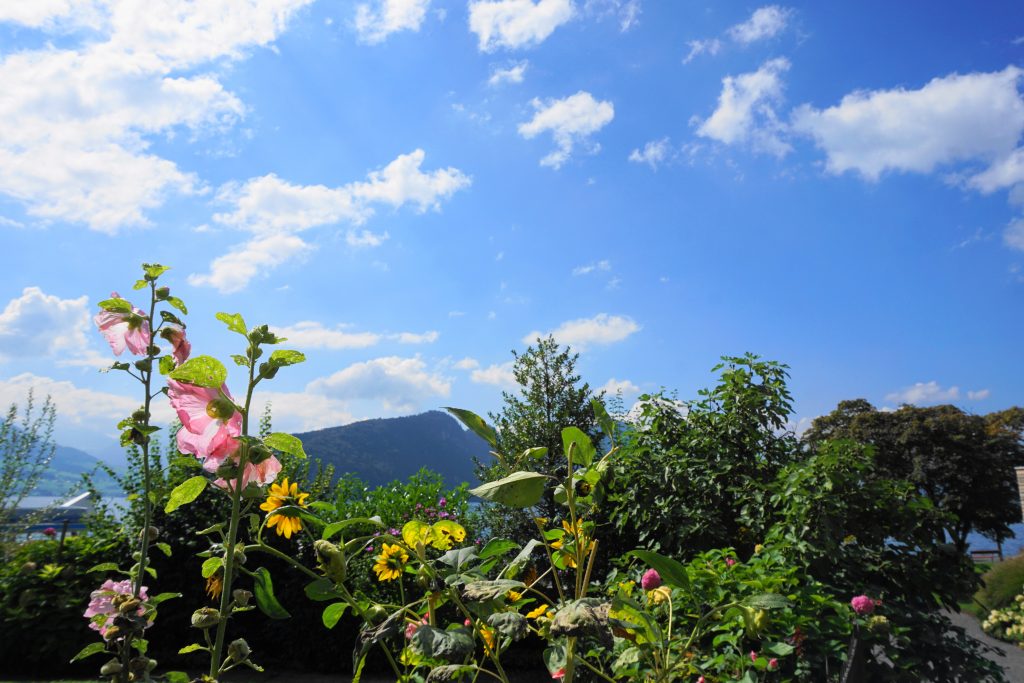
left=0, top=0, right=1024, bottom=458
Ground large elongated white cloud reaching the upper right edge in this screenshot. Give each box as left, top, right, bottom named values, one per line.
left=793, top=67, right=1024, bottom=181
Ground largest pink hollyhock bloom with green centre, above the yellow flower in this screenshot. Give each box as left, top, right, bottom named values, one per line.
left=173, top=380, right=242, bottom=458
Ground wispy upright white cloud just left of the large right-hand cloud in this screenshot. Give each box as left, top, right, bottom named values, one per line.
left=697, top=57, right=791, bottom=157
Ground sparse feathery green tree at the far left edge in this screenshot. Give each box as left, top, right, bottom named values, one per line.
left=0, top=391, right=56, bottom=542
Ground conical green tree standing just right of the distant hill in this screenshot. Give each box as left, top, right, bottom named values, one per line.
left=475, top=336, right=604, bottom=542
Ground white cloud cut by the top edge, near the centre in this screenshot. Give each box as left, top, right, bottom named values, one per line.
left=469, top=0, right=574, bottom=52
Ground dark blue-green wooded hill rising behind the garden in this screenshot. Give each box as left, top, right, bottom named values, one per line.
left=296, top=411, right=489, bottom=486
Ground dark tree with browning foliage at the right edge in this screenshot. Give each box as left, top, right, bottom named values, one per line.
left=804, top=398, right=1024, bottom=553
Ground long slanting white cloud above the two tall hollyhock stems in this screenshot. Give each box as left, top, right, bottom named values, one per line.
left=188, top=150, right=471, bottom=293
